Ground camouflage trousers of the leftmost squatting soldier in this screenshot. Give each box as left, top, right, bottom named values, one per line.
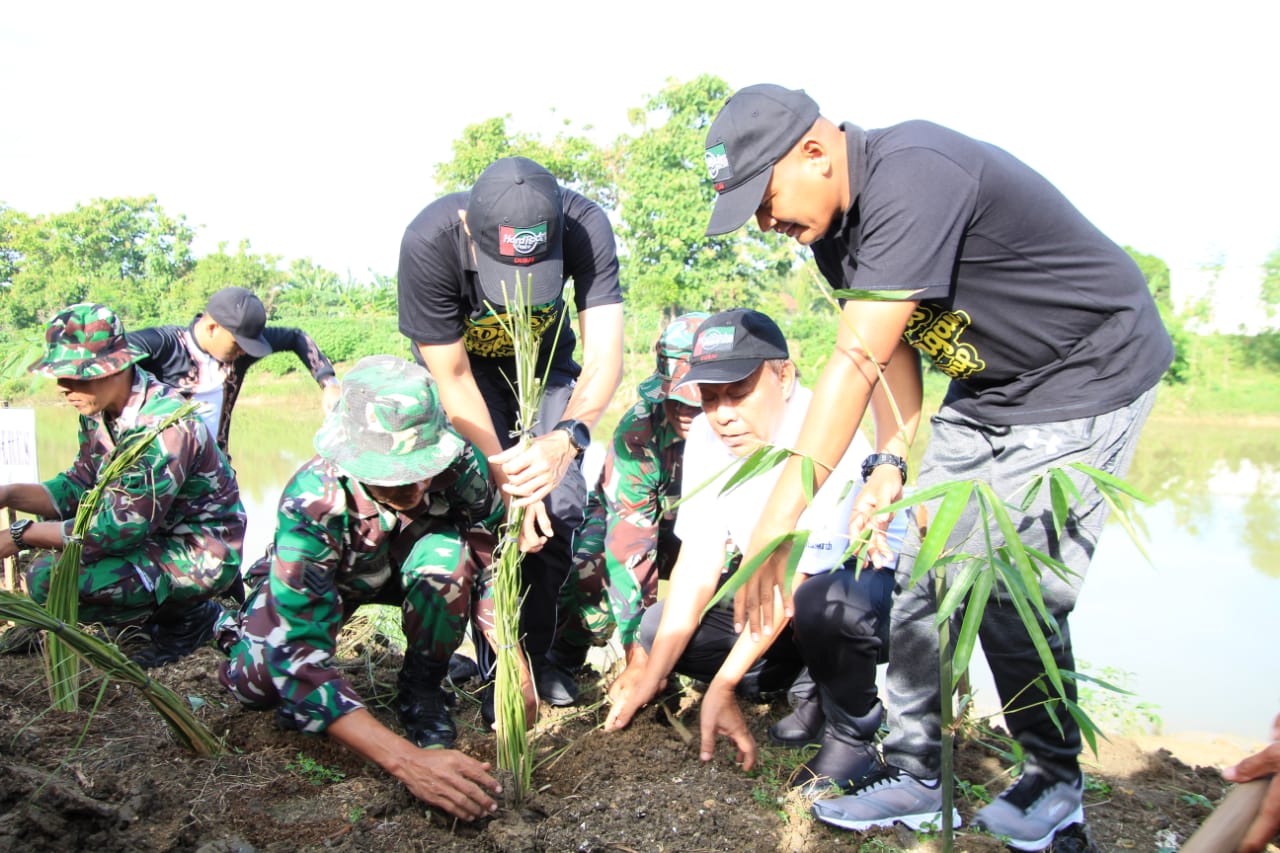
left=27, top=534, right=239, bottom=625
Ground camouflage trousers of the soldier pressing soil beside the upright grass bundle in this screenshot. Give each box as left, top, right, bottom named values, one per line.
left=216, top=530, right=483, bottom=731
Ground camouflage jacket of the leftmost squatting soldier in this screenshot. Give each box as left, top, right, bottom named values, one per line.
left=44, top=369, right=244, bottom=566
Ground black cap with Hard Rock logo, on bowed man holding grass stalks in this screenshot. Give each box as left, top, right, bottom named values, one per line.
left=467, top=158, right=564, bottom=305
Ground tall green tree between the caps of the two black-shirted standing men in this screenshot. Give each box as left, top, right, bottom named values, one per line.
left=617, top=74, right=799, bottom=314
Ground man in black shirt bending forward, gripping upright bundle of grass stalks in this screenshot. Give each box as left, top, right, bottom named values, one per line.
left=399, top=158, right=622, bottom=704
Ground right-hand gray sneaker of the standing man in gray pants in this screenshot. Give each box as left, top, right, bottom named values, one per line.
left=974, top=771, right=1084, bottom=850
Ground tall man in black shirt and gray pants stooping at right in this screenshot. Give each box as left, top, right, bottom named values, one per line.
left=707, top=85, right=1172, bottom=850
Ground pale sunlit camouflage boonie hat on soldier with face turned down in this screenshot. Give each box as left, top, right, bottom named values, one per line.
left=315, top=355, right=466, bottom=485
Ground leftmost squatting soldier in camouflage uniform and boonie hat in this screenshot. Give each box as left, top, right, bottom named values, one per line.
left=0, top=304, right=244, bottom=667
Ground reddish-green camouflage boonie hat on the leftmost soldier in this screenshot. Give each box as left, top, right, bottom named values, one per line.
left=27, top=302, right=147, bottom=379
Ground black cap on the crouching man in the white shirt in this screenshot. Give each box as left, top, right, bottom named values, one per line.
left=676, top=309, right=791, bottom=388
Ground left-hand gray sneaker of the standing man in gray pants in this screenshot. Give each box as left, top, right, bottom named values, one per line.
left=813, top=767, right=960, bottom=831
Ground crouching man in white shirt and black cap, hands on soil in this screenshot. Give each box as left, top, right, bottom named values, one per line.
left=605, top=309, right=893, bottom=793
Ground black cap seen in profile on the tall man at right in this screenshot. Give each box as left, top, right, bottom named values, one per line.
left=705, top=83, right=819, bottom=237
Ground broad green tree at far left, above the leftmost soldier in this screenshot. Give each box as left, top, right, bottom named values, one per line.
left=0, top=196, right=195, bottom=329
